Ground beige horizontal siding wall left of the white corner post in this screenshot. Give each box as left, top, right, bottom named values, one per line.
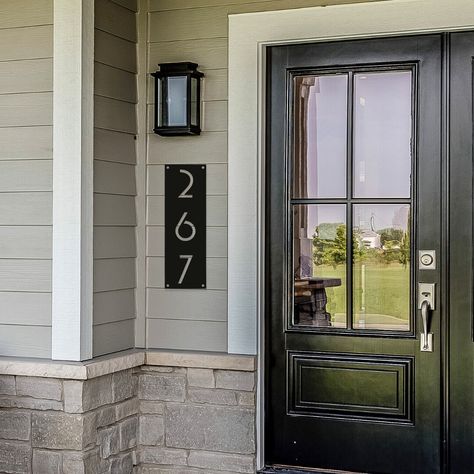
left=0, top=0, right=53, bottom=357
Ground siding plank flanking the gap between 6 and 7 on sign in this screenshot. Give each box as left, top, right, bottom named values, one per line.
left=146, top=226, right=227, bottom=257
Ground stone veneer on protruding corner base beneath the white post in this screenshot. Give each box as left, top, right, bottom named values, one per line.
left=0, top=369, right=138, bottom=474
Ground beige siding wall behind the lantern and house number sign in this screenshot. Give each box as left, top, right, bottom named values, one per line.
left=146, top=0, right=374, bottom=351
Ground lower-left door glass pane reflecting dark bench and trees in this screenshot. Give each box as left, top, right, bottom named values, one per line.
left=293, top=204, right=347, bottom=327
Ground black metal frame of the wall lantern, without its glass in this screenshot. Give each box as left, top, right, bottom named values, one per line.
left=151, top=62, right=204, bottom=136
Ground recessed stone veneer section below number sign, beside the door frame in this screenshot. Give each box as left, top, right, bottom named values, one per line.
left=137, top=366, right=255, bottom=474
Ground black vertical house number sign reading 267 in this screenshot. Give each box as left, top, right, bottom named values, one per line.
left=165, top=165, right=206, bottom=289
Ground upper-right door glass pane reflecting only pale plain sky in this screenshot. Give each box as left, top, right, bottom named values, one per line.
left=354, top=71, right=412, bottom=197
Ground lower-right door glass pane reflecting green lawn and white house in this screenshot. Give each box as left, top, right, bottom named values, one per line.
left=353, top=204, right=411, bottom=331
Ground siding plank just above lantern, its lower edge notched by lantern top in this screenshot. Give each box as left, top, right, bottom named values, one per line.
left=148, top=38, right=227, bottom=72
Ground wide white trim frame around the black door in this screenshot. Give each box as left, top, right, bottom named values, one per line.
left=228, top=0, right=474, bottom=469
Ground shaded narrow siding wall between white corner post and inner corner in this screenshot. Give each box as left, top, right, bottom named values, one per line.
left=93, top=0, right=137, bottom=356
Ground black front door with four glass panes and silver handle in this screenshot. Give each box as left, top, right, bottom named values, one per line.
left=265, top=33, right=474, bottom=473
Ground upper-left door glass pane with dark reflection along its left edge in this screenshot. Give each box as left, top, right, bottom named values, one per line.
left=293, top=74, right=347, bottom=198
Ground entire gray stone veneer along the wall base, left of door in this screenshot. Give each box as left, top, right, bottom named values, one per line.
left=0, top=354, right=255, bottom=474
